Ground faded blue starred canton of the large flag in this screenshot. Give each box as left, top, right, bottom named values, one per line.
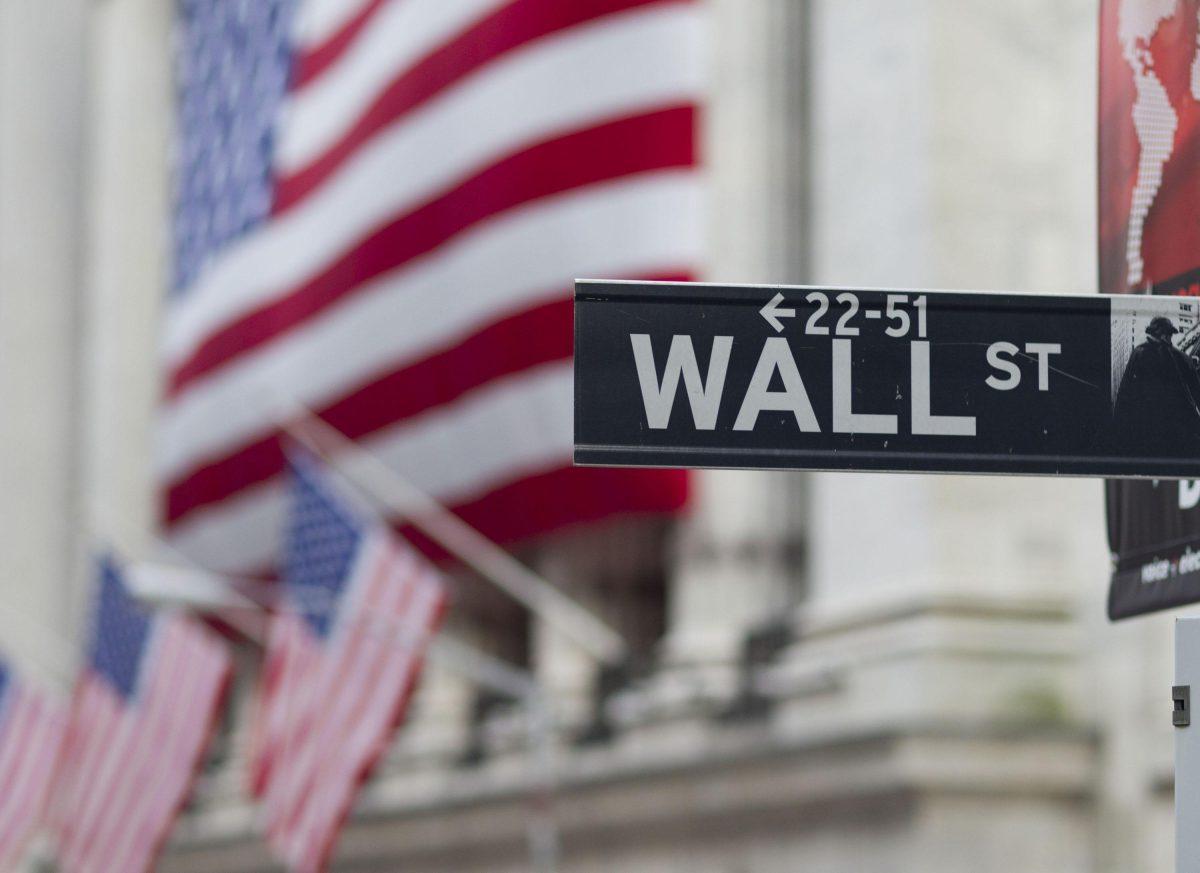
left=173, top=0, right=295, bottom=291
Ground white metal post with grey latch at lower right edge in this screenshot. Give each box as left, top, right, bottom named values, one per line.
left=1171, top=616, right=1200, bottom=873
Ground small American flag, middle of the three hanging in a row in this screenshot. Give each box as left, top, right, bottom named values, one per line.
left=53, top=559, right=229, bottom=873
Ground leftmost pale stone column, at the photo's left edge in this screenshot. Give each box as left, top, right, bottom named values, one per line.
left=0, top=0, right=91, bottom=684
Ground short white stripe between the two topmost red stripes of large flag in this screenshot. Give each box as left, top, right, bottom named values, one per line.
left=276, top=0, right=506, bottom=175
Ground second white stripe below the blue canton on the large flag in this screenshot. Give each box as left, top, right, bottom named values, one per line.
left=158, top=170, right=703, bottom=482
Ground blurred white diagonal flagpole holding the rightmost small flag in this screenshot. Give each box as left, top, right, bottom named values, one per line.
left=278, top=399, right=628, bottom=664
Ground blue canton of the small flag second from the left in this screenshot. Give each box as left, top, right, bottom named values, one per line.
left=88, top=558, right=151, bottom=699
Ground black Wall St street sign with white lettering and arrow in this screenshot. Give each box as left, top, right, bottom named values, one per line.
left=575, top=282, right=1200, bottom=478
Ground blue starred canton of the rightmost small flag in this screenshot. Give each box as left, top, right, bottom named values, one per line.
left=283, top=454, right=366, bottom=637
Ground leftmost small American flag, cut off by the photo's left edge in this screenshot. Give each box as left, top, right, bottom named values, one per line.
left=0, top=661, right=67, bottom=871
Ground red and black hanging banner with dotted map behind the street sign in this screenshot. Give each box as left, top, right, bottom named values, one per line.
left=1099, top=0, right=1200, bottom=619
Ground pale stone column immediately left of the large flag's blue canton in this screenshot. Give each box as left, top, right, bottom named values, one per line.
left=82, top=0, right=174, bottom=568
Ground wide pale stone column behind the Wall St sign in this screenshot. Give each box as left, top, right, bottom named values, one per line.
left=774, top=0, right=1106, bottom=743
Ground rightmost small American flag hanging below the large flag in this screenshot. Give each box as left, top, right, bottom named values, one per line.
left=252, top=454, right=445, bottom=871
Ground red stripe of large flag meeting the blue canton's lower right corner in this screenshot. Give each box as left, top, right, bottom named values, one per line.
left=275, top=0, right=691, bottom=212
